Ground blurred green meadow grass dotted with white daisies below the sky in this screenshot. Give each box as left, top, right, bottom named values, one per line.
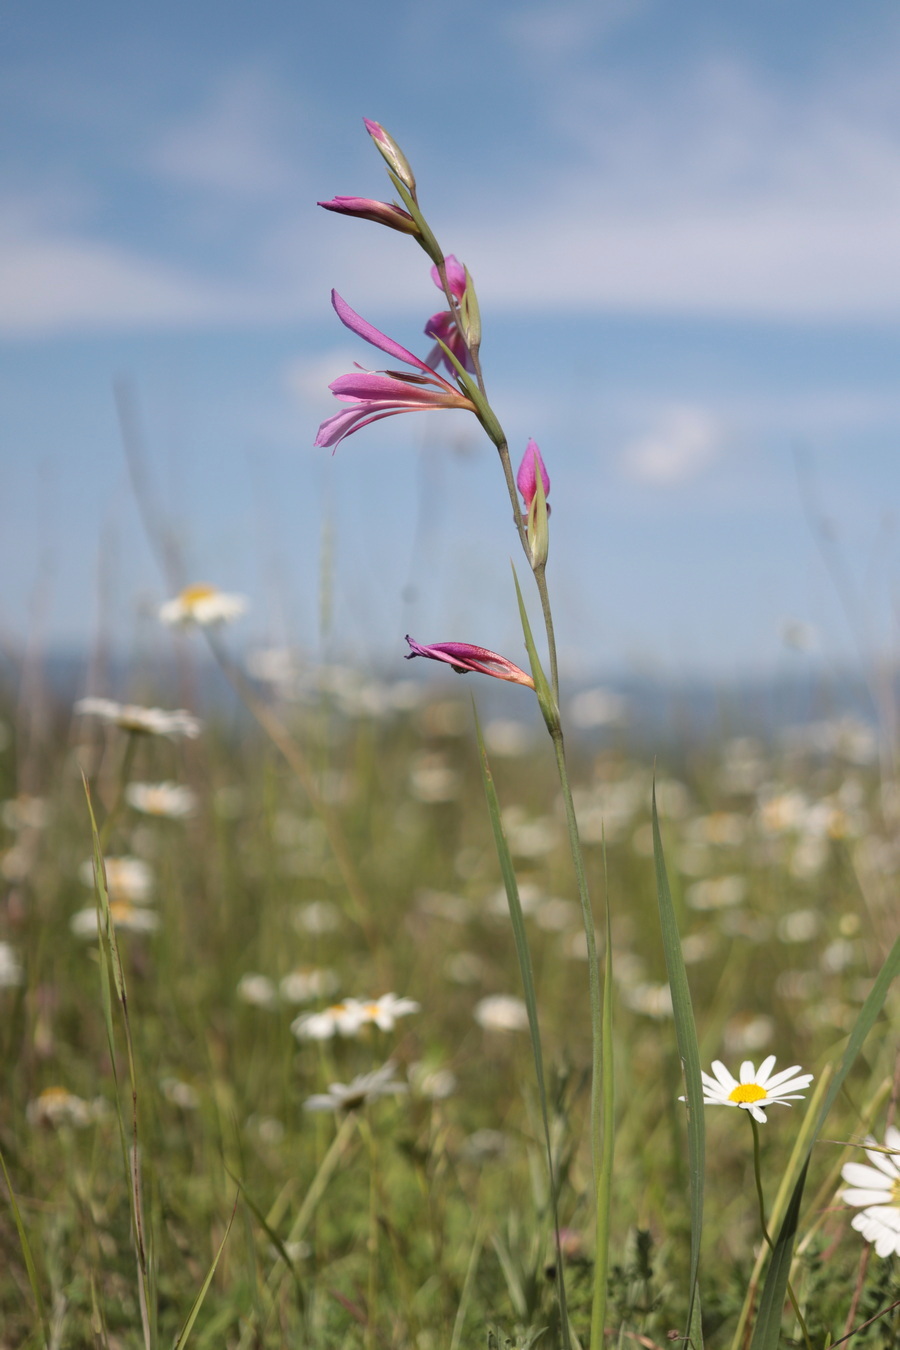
left=0, top=676, right=900, bottom=1350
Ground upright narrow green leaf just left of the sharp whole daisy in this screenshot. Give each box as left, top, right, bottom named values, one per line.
left=653, top=782, right=706, bottom=1350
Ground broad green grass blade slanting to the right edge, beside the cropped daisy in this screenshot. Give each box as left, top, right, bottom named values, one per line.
left=750, top=937, right=900, bottom=1350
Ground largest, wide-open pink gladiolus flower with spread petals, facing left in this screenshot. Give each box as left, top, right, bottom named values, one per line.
left=314, top=290, right=475, bottom=448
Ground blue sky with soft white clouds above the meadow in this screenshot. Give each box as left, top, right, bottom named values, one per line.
left=0, top=0, right=900, bottom=672
